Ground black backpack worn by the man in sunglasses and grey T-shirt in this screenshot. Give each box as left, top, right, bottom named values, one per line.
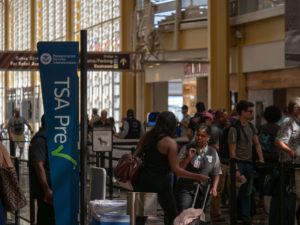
left=219, top=120, right=255, bottom=164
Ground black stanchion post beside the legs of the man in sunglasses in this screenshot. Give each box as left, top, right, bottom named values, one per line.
left=229, top=158, right=237, bottom=225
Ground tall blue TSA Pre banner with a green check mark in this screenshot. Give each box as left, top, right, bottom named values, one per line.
left=37, top=42, right=79, bottom=225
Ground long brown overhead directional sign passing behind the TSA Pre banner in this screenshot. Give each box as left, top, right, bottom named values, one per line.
left=0, top=51, right=131, bottom=71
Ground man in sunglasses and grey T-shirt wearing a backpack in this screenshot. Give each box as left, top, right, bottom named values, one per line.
left=228, top=100, right=264, bottom=225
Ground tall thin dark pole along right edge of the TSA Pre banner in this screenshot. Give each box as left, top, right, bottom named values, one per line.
left=80, top=30, right=88, bottom=225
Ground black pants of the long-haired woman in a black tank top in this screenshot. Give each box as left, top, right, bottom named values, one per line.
left=134, top=171, right=177, bottom=225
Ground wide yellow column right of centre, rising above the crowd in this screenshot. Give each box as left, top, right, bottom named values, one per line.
left=208, top=0, right=230, bottom=110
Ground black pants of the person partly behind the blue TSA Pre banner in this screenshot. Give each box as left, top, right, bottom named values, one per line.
left=36, top=199, right=55, bottom=225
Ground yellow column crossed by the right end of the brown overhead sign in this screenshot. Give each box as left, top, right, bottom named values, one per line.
left=120, top=0, right=136, bottom=117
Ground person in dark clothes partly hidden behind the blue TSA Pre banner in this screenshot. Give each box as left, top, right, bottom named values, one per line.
left=29, top=115, right=55, bottom=225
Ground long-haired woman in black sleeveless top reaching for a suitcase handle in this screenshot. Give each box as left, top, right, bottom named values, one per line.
left=134, top=111, right=208, bottom=225
